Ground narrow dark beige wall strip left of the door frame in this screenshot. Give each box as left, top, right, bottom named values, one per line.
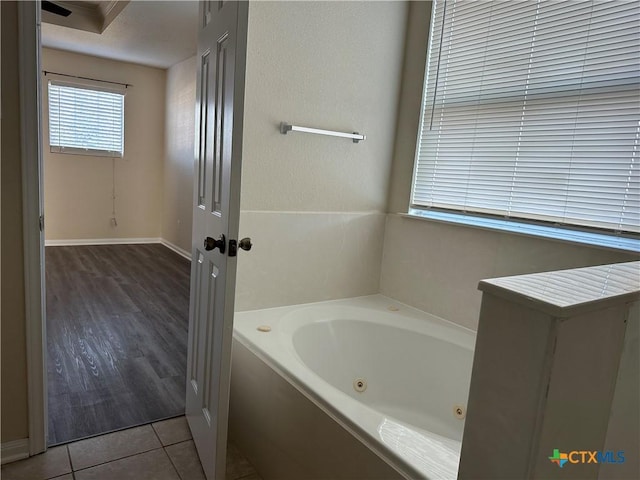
left=0, top=2, right=29, bottom=443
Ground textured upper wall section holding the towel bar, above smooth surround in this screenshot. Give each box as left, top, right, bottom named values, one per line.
left=242, top=2, right=406, bottom=212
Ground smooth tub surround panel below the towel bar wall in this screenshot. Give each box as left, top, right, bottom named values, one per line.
left=236, top=211, right=385, bottom=311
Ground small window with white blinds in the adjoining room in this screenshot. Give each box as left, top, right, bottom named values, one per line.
left=49, top=81, right=124, bottom=157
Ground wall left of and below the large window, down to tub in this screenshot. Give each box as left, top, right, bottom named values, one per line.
left=380, top=2, right=638, bottom=330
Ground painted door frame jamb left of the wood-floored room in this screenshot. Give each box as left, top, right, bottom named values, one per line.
left=17, top=0, right=48, bottom=455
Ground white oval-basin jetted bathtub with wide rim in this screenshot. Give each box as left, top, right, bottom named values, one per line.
left=232, top=295, right=475, bottom=479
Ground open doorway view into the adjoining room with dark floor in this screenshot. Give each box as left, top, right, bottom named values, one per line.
left=41, top=1, right=198, bottom=446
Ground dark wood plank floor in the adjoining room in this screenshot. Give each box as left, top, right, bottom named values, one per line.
left=45, top=244, right=189, bottom=445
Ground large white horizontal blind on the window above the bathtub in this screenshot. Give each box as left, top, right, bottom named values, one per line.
left=411, top=0, right=640, bottom=232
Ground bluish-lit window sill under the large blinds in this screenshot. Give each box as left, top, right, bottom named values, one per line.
left=400, top=208, right=640, bottom=253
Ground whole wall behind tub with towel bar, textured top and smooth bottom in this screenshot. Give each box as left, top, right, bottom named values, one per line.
left=236, top=2, right=407, bottom=310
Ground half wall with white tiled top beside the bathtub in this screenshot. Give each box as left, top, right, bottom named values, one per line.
left=458, top=262, right=640, bottom=480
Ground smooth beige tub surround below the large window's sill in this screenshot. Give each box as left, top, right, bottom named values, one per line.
left=380, top=214, right=638, bottom=330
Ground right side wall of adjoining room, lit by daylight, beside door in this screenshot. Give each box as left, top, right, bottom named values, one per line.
left=162, top=56, right=196, bottom=252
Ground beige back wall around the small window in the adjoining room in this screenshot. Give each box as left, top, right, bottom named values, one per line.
left=42, top=48, right=165, bottom=240
